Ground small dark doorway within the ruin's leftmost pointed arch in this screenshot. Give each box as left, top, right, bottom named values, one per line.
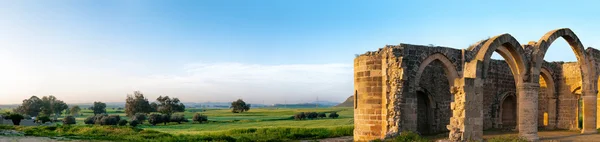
left=417, top=91, right=433, bottom=135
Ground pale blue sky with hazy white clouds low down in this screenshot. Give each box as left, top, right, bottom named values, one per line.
left=0, top=0, right=600, bottom=104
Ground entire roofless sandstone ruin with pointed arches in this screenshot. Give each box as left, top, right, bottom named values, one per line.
left=354, top=28, right=600, bottom=141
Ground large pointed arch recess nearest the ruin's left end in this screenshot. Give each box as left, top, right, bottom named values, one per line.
left=414, top=53, right=458, bottom=135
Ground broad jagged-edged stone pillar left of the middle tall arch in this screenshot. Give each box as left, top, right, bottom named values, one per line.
left=447, top=78, right=483, bottom=141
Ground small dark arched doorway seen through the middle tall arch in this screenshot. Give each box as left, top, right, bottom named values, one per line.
left=501, top=94, right=517, bottom=130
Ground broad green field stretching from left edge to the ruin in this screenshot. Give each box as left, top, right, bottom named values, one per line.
left=5, top=108, right=354, bottom=141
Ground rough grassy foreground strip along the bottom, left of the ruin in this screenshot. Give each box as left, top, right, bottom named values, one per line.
left=0, top=125, right=354, bottom=142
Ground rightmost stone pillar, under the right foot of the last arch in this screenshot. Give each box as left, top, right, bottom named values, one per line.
left=581, top=90, right=598, bottom=134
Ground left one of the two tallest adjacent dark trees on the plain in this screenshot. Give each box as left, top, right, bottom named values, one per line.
left=125, top=91, right=152, bottom=116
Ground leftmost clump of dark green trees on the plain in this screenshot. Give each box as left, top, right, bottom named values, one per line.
left=13, top=95, right=69, bottom=120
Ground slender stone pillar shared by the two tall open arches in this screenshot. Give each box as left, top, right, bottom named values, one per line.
left=517, top=82, right=540, bottom=141
